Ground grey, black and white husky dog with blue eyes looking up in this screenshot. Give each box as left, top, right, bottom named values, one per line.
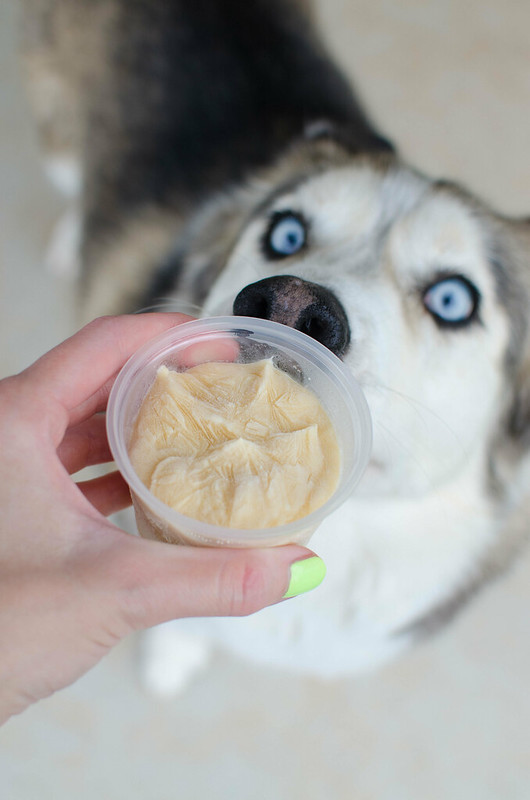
left=20, top=0, right=530, bottom=690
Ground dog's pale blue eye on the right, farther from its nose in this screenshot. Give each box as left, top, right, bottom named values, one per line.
left=423, top=275, right=479, bottom=326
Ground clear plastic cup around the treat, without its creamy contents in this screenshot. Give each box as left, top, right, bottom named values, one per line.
left=107, top=317, right=372, bottom=547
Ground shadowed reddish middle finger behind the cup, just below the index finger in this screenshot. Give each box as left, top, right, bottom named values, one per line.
left=57, top=414, right=113, bottom=475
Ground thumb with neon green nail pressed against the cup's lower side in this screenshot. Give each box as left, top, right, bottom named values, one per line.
left=111, top=537, right=326, bottom=630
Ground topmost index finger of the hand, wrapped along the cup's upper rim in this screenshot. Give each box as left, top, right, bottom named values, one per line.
left=21, top=312, right=191, bottom=422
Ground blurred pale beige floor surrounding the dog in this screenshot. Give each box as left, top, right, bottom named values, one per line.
left=0, top=0, right=530, bottom=800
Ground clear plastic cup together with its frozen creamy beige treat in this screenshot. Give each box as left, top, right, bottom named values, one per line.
left=107, top=317, right=372, bottom=547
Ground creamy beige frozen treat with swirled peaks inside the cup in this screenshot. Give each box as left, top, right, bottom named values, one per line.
left=129, top=359, right=341, bottom=529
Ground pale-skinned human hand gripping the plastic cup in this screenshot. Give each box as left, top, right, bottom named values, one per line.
left=0, top=314, right=313, bottom=723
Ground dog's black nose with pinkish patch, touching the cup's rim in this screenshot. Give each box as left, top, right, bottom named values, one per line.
left=233, top=275, right=350, bottom=356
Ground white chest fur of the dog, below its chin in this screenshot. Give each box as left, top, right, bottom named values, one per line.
left=169, top=476, right=496, bottom=677
